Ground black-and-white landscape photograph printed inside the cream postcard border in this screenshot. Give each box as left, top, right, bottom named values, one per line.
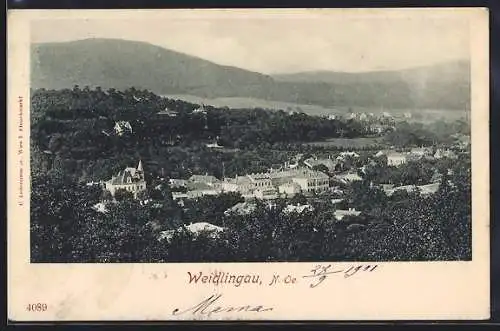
left=29, top=11, right=472, bottom=263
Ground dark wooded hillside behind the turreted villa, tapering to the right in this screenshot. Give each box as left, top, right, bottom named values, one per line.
left=31, top=86, right=364, bottom=181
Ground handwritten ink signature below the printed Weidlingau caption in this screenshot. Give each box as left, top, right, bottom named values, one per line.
left=172, top=294, right=273, bottom=317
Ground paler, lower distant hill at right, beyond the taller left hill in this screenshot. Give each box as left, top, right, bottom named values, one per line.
left=273, top=61, right=470, bottom=109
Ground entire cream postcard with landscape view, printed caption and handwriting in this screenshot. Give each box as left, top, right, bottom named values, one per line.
left=8, top=8, right=489, bottom=321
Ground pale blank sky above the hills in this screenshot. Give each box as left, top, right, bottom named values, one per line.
left=31, top=10, right=470, bottom=74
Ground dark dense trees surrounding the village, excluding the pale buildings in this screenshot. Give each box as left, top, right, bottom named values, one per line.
left=31, top=86, right=471, bottom=262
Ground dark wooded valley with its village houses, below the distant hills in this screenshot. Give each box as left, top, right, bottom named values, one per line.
left=32, top=87, right=470, bottom=262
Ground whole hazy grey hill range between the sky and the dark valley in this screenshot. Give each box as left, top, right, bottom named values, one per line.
left=31, top=39, right=470, bottom=110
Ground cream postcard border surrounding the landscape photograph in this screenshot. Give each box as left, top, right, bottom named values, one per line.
left=7, top=8, right=490, bottom=321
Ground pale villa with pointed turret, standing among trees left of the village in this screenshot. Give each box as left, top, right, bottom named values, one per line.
left=105, top=160, right=146, bottom=198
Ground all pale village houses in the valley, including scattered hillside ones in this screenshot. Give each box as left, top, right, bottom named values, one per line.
left=56, top=91, right=470, bottom=254
